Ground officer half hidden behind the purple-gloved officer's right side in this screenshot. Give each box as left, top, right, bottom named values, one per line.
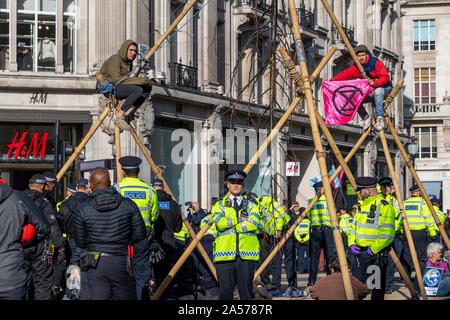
left=378, top=177, right=403, bottom=294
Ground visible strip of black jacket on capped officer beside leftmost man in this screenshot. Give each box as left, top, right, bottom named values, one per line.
left=25, top=190, right=65, bottom=250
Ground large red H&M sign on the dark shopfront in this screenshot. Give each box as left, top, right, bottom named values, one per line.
left=6, top=132, right=48, bottom=160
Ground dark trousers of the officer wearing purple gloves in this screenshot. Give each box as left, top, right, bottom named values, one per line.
left=351, top=251, right=387, bottom=300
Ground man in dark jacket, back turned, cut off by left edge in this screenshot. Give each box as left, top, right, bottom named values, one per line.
left=0, top=183, right=50, bottom=300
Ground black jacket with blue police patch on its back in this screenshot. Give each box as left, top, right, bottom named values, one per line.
left=155, top=190, right=183, bottom=252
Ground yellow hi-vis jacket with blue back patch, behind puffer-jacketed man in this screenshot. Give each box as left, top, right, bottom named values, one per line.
left=115, top=177, right=159, bottom=227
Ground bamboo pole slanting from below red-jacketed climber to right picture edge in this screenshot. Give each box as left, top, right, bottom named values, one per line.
left=384, top=114, right=450, bottom=248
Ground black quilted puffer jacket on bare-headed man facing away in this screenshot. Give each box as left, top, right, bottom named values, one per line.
left=73, top=187, right=146, bottom=255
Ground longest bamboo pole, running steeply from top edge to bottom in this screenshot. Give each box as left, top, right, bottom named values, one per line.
left=289, top=0, right=354, bottom=300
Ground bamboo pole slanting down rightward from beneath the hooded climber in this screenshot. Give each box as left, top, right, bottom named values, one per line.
left=130, top=128, right=217, bottom=280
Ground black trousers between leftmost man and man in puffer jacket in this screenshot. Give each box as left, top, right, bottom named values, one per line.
left=23, top=241, right=53, bottom=300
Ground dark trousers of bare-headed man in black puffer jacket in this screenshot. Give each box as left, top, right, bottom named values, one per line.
left=87, top=256, right=137, bottom=300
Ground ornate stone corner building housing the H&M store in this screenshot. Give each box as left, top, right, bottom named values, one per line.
left=0, top=0, right=406, bottom=208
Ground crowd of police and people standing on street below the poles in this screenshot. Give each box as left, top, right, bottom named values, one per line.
left=0, top=161, right=450, bottom=300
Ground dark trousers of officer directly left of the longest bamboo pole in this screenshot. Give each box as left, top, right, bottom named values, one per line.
left=308, top=228, right=336, bottom=283
